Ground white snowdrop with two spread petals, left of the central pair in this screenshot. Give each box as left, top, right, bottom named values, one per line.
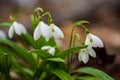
left=8, top=21, right=27, bottom=38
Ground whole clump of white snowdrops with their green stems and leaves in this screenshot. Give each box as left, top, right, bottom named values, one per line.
left=0, top=7, right=113, bottom=80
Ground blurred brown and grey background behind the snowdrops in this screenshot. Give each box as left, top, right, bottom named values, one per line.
left=0, top=0, right=120, bottom=80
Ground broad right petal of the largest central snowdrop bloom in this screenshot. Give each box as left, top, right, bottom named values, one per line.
left=41, top=22, right=52, bottom=41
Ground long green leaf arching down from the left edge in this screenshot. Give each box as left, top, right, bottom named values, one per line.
left=0, top=38, right=36, bottom=68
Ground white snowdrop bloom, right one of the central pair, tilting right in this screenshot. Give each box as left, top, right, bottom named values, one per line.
left=50, top=23, right=64, bottom=39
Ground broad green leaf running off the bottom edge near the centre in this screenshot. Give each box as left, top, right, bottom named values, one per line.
left=50, top=68, right=74, bottom=80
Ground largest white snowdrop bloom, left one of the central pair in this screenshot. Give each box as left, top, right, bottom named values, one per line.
left=33, top=21, right=52, bottom=41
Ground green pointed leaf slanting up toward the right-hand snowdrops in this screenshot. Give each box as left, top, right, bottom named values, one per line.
left=55, top=46, right=87, bottom=58
